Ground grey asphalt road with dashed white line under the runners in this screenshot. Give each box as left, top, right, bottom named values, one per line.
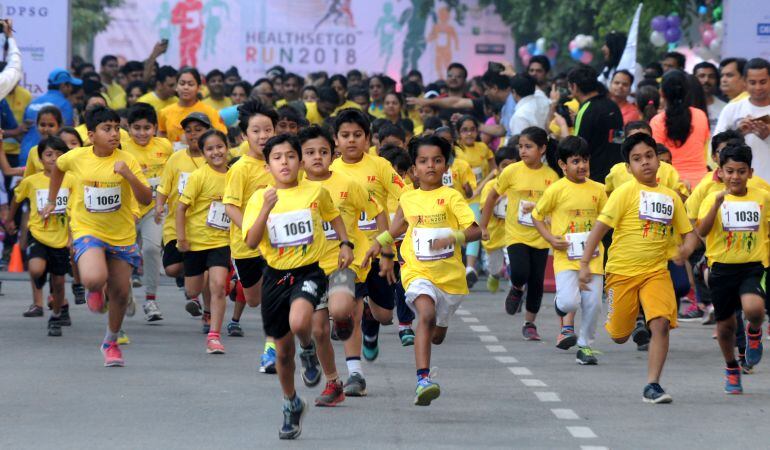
left=0, top=277, right=770, bottom=449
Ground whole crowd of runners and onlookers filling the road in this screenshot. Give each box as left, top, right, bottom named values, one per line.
left=0, top=34, right=770, bottom=439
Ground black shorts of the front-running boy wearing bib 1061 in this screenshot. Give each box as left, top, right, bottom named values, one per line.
left=262, top=263, right=328, bottom=339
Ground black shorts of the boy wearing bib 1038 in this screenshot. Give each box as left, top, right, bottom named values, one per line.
left=709, top=262, right=767, bottom=321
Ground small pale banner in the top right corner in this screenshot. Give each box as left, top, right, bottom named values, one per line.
left=722, top=0, right=770, bottom=59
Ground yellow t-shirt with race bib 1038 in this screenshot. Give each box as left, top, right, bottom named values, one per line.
left=698, top=188, right=770, bottom=267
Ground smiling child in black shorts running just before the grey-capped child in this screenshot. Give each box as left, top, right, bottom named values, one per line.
left=175, top=130, right=230, bottom=354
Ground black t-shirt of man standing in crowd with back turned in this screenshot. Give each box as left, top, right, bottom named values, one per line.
left=577, top=94, right=623, bottom=183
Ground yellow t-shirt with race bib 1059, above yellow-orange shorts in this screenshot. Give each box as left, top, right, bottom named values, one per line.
left=597, top=180, right=692, bottom=277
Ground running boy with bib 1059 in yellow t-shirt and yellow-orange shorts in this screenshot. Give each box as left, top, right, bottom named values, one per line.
left=580, top=133, right=698, bottom=403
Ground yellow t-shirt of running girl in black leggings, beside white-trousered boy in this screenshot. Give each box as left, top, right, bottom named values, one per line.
left=495, top=161, right=559, bottom=249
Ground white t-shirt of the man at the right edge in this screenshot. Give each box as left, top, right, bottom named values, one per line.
left=713, top=98, right=770, bottom=180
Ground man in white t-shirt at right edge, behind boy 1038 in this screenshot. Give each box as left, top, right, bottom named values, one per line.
left=714, top=58, right=770, bottom=180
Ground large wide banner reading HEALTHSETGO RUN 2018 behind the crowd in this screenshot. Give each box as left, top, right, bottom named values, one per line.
left=94, top=0, right=514, bottom=82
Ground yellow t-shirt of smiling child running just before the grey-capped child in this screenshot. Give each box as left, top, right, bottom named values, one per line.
left=179, top=164, right=230, bottom=252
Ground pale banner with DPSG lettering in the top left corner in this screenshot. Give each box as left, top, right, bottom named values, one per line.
left=0, top=0, right=70, bottom=97
